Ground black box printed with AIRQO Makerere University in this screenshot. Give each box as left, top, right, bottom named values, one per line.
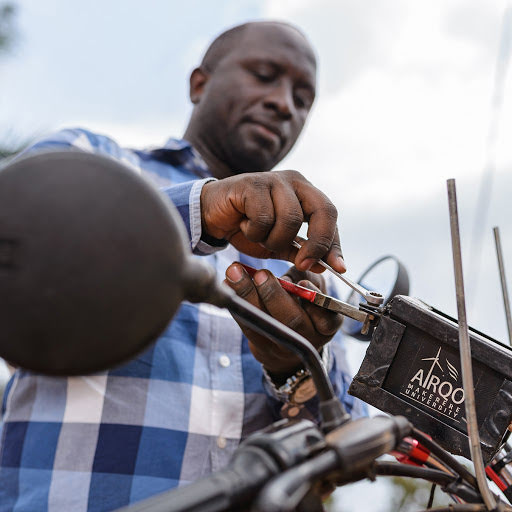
left=349, top=295, right=512, bottom=462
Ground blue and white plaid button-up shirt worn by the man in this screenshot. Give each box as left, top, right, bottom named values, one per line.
left=0, top=129, right=365, bottom=512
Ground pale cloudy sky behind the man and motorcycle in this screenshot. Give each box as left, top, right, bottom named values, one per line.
left=0, top=0, right=512, bottom=512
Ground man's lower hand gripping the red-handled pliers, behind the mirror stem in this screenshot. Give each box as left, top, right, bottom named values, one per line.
left=226, top=263, right=343, bottom=374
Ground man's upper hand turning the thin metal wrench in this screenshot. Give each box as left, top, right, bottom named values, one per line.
left=201, top=171, right=346, bottom=272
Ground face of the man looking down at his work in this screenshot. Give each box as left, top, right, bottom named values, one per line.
left=192, top=24, right=316, bottom=173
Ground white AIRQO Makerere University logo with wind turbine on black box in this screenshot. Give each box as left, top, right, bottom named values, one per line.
left=400, top=347, right=464, bottom=422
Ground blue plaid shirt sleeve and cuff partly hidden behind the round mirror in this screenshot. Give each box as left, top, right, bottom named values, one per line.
left=18, top=128, right=227, bottom=255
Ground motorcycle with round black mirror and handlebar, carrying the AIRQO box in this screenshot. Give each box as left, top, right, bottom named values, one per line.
left=0, top=152, right=512, bottom=512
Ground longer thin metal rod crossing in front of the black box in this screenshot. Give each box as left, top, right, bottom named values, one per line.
left=447, top=179, right=496, bottom=510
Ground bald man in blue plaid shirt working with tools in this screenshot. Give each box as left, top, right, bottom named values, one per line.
left=0, top=22, right=361, bottom=511
